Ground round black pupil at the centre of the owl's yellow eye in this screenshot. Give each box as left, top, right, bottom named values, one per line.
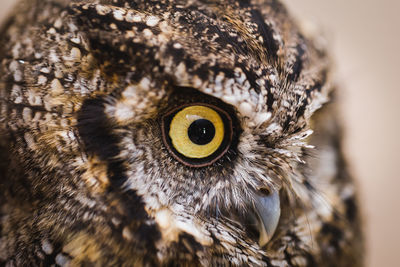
left=188, top=119, right=215, bottom=145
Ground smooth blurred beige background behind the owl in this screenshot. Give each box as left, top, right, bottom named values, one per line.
left=0, top=0, right=400, bottom=267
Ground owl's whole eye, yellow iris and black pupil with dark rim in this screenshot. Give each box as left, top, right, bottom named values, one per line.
left=162, top=103, right=232, bottom=167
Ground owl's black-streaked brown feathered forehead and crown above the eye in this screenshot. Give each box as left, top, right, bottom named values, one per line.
left=70, top=1, right=327, bottom=129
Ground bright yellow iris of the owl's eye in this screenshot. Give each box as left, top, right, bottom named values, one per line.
left=169, top=106, right=224, bottom=159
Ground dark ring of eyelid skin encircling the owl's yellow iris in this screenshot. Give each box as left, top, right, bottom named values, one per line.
left=161, top=102, right=233, bottom=168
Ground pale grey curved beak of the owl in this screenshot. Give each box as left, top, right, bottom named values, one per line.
left=254, top=192, right=281, bottom=247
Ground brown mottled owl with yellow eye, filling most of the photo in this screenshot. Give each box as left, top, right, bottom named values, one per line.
left=0, top=0, right=363, bottom=267
